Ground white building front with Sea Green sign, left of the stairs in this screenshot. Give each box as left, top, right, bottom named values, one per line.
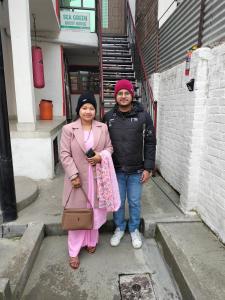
left=0, top=0, right=125, bottom=179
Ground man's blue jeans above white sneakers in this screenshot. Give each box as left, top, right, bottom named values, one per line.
left=113, top=172, right=142, bottom=232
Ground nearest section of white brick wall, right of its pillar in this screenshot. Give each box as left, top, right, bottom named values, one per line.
left=198, top=44, right=225, bottom=242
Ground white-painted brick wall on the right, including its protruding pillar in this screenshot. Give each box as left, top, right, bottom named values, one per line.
left=155, top=44, right=225, bottom=242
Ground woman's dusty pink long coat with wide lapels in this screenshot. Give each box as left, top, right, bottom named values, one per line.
left=60, top=119, right=113, bottom=208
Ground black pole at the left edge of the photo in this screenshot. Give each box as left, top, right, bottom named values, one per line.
left=0, top=32, right=17, bottom=222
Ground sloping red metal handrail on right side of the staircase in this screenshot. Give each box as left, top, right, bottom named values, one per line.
left=126, top=0, right=157, bottom=130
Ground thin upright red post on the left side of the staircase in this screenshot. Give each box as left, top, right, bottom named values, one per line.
left=97, top=0, right=104, bottom=119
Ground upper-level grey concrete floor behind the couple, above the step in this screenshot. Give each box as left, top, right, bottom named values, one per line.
left=11, top=167, right=191, bottom=229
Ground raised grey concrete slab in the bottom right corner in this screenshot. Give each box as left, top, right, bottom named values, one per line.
left=156, top=223, right=225, bottom=300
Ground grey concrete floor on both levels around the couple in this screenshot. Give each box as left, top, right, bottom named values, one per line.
left=0, top=168, right=200, bottom=300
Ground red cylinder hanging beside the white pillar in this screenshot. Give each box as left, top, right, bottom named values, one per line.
left=32, top=46, right=45, bottom=89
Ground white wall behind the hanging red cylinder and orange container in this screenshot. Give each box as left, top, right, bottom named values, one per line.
left=35, top=42, right=63, bottom=116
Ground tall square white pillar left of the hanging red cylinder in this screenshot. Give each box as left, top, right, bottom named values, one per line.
left=8, top=0, right=36, bottom=131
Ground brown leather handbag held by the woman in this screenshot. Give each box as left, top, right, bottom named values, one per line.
left=62, top=188, right=93, bottom=230
